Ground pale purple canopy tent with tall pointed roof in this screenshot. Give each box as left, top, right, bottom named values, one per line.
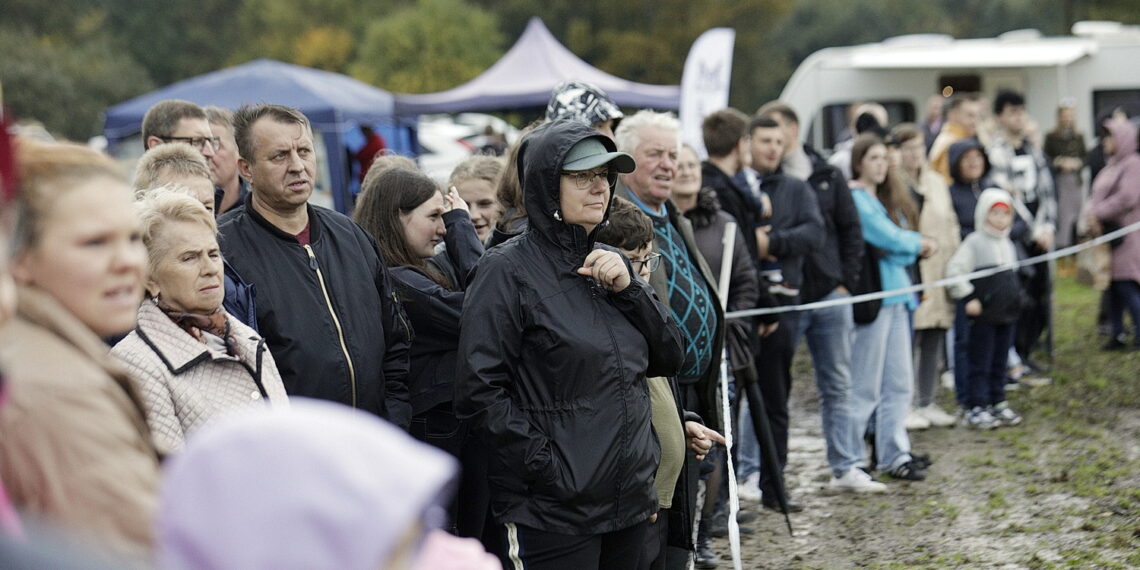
left=396, top=17, right=681, bottom=115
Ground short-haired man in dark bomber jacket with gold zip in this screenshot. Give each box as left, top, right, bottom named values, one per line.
left=218, top=105, right=412, bottom=429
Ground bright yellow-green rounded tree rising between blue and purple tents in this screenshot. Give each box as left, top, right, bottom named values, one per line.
left=349, top=0, right=504, bottom=92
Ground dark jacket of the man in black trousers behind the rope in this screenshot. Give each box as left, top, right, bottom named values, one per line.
left=734, top=172, right=824, bottom=288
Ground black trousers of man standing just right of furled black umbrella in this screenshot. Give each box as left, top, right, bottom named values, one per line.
left=756, top=312, right=799, bottom=500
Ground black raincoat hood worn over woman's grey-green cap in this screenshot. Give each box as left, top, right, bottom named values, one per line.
left=516, top=119, right=617, bottom=254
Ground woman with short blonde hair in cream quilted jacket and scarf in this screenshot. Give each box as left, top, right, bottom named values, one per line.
left=112, top=190, right=288, bottom=450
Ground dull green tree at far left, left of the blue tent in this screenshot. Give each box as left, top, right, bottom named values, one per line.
left=0, top=27, right=154, bottom=140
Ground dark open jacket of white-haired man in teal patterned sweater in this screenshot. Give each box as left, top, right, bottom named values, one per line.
left=616, top=179, right=724, bottom=431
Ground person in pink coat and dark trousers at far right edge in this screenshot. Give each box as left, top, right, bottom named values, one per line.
left=1089, top=119, right=1140, bottom=350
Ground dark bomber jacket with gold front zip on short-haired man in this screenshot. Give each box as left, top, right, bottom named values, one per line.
left=218, top=194, right=412, bottom=428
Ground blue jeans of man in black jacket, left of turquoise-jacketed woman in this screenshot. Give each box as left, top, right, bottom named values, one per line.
left=796, top=291, right=862, bottom=477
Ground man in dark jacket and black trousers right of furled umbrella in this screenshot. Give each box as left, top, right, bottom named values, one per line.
left=723, top=117, right=823, bottom=511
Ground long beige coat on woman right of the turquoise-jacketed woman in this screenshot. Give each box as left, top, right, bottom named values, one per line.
left=907, top=168, right=961, bottom=331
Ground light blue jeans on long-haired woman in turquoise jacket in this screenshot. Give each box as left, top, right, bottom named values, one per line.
left=850, top=303, right=914, bottom=471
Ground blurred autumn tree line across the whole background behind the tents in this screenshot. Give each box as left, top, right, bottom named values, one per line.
left=0, top=0, right=1140, bottom=140
